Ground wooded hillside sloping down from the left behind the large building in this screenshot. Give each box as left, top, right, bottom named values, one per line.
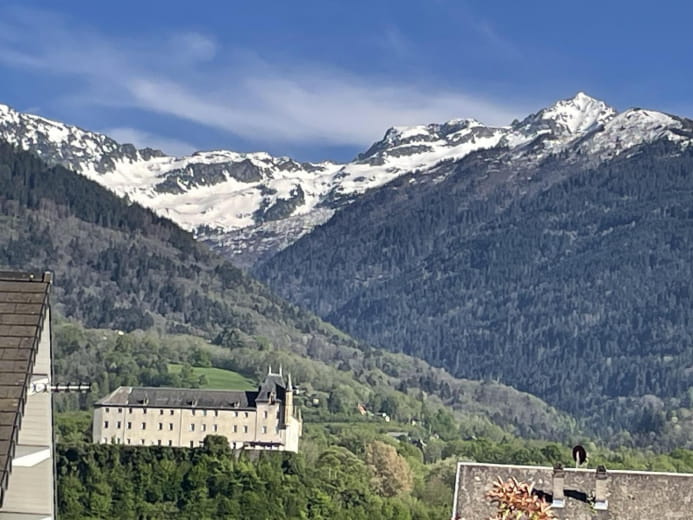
left=0, top=144, right=575, bottom=439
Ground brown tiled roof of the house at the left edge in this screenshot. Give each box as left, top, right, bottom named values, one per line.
left=0, top=271, right=51, bottom=506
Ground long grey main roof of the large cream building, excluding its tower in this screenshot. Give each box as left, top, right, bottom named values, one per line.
left=96, top=386, right=258, bottom=410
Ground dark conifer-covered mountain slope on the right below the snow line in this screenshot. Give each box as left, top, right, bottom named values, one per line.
left=257, top=143, right=693, bottom=446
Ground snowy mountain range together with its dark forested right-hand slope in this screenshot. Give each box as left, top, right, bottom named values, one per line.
left=0, top=93, right=693, bottom=446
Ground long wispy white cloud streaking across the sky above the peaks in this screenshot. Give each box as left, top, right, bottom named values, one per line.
left=0, top=10, right=524, bottom=149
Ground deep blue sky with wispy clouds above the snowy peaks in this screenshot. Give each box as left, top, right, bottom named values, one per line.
left=0, top=0, right=693, bottom=160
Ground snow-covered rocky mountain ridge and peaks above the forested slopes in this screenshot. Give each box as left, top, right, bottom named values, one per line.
left=0, top=93, right=690, bottom=268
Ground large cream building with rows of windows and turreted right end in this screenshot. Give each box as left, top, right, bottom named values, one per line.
left=93, top=369, right=302, bottom=452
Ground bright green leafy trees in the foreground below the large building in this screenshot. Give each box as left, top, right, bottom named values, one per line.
left=57, top=426, right=693, bottom=520
